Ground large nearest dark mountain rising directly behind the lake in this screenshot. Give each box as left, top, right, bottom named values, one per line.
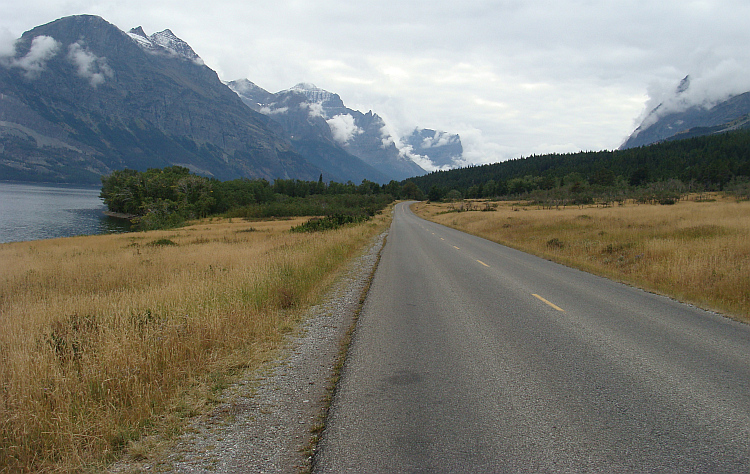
left=0, top=15, right=346, bottom=183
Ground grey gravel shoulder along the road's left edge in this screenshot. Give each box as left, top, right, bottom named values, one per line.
left=110, top=231, right=387, bottom=473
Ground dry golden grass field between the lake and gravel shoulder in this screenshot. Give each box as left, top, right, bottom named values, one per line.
left=0, top=213, right=389, bottom=472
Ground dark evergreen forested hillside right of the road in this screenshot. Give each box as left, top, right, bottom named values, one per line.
left=410, top=130, right=750, bottom=202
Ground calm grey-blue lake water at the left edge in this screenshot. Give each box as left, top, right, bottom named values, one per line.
left=0, top=182, right=127, bottom=243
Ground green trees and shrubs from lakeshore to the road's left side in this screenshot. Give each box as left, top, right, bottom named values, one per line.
left=100, top=166, right=426, bottom=230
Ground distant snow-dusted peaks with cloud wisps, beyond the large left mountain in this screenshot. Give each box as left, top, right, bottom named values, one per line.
left=228, top=79, right=463, bottom=180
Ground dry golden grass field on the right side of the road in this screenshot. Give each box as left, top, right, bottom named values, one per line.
left=413, top=196, right=750, bottom=321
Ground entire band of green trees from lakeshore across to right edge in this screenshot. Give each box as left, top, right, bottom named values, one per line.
left=101, top=130, right=750, bottom=229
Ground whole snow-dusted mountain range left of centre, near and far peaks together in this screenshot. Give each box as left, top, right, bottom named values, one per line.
left=0, top=15, right=458, bottom=183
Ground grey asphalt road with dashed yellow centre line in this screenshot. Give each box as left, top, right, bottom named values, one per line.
left=313, top=204, right=750, bottom=473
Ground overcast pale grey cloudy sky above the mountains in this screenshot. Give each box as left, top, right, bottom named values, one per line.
left=0, top=0, right=750, bottom=168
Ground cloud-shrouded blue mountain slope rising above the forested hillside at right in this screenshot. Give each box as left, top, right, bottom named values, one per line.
left=620, top=76, right=750, bottom=149
